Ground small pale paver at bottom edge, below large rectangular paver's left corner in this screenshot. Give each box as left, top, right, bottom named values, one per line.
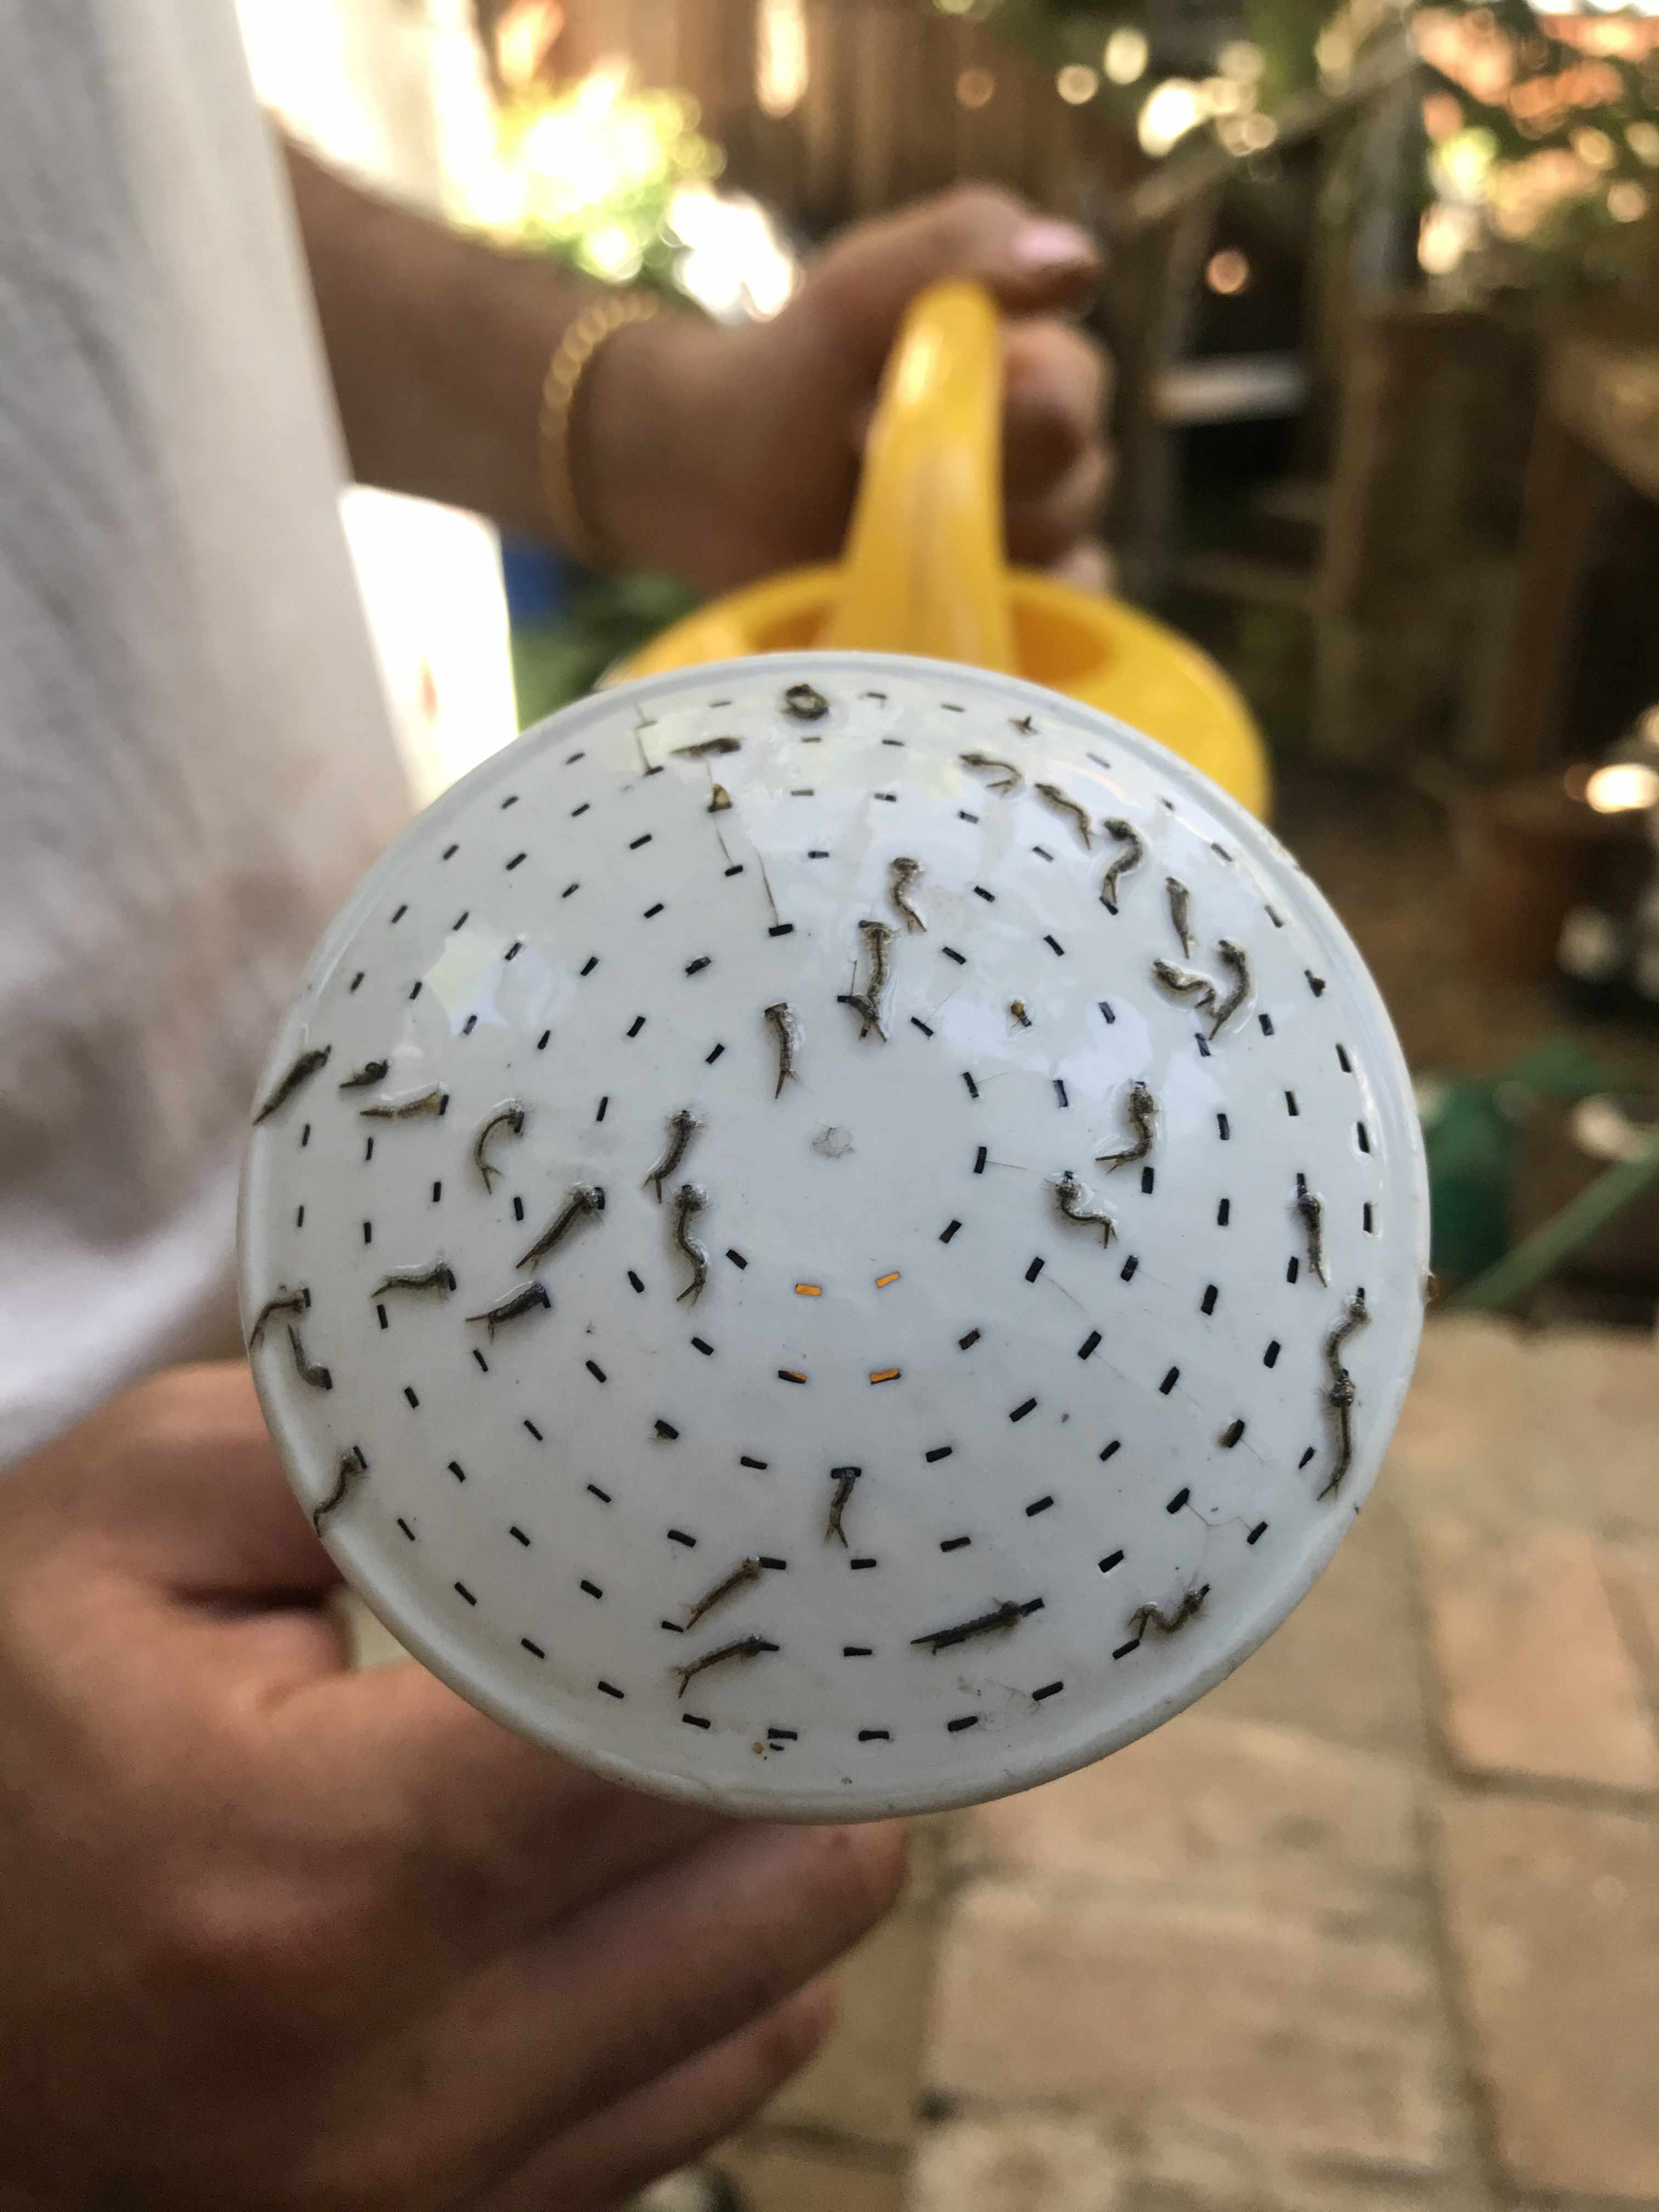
left=905, top=2113, right=1126, bottom=2212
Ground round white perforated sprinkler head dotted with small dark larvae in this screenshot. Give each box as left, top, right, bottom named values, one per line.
left=241, top=652, right=1427, bottom=1818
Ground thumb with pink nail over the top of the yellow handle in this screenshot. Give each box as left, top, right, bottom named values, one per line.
left=801, top=184, right=1099, bottom=374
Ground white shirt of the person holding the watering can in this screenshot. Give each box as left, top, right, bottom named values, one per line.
left=0, top=0, right=407, bottom=1464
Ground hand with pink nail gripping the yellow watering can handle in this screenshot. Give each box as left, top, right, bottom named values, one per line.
left=575, top=186, right=1110, bottom=591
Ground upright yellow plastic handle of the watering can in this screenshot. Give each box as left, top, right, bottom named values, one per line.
left=821, top=281, right=1015, bottom=670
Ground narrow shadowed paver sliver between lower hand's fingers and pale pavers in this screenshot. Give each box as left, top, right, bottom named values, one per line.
left=765, top=1818, right=951, bottom=2150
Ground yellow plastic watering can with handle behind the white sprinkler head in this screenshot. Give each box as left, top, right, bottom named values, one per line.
left=613, top=283, right=1267, bottom=814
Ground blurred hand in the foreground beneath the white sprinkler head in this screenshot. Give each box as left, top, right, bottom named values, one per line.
left=0, top=1367, right=900, bottom=2212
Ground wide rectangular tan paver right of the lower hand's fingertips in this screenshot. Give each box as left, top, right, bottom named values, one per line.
left=929, top=1880, right=1444, bottom=2172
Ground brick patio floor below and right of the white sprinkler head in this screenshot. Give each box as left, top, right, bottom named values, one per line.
left=725, top=1318, right=1659, bottom=2212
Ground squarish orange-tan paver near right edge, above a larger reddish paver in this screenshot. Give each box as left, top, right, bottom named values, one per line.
left=1420, top=1522, right=1659, bottom=1790
